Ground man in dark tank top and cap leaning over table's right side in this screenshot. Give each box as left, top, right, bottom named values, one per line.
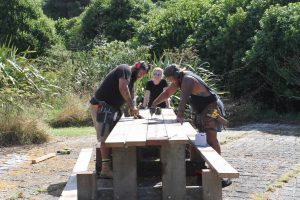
left=151, top=64, right=231, bottom=186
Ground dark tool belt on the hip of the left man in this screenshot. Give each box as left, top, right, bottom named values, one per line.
left=97, top=101, right=122, bottom=136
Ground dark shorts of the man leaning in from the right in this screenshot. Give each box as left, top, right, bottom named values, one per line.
left=195, top=102, right=222, bottom=132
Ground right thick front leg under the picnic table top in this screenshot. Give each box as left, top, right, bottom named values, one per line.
left=161, top=144, right=186, bottom=200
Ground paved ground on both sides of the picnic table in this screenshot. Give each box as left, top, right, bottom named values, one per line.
left=0, top=124, right=300, bottom=200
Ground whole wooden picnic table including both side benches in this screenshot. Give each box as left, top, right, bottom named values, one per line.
left=69, top=109, right=239, bottom=200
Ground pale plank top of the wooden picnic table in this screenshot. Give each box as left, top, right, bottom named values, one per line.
left=105, top=109, right=196, bottom=147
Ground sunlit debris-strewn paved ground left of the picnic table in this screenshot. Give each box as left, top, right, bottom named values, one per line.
left=0, top=135, right=96, bottom=200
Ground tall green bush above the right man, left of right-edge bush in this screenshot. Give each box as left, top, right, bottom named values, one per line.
left=192, top=0, right=295, bottom=74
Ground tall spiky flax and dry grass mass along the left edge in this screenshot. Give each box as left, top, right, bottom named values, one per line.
left=0, top=43, right=55, bottom=146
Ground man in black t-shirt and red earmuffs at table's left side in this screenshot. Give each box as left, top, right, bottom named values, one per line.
left=90, top=61, right=151, bottom=177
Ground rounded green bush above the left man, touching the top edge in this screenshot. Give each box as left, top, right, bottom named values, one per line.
left=74, top=0, right=151, bottom=47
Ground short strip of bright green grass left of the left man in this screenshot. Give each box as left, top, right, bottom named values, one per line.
left=50, top=127, right=96, bottom=137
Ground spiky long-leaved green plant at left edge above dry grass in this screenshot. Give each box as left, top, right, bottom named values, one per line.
left=0, top=44, right=57, bottom=109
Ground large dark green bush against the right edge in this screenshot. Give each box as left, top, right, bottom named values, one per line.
left=245, top=3, right=300, bottom=110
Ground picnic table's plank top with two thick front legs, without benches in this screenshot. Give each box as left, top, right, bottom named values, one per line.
left=105, top=109, right=191, bottom=200
